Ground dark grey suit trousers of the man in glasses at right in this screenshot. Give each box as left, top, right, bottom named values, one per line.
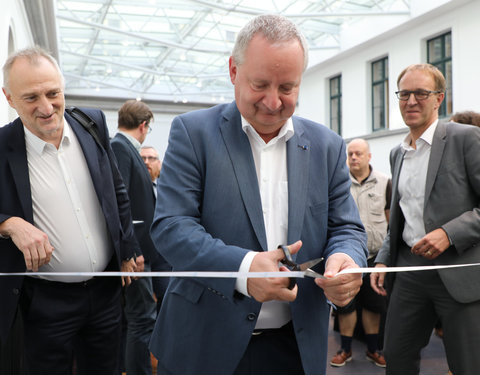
left=384, top=270, right=480, bottom=375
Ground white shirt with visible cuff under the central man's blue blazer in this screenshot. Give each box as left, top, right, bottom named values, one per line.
left=236, top=117, right=294, bottom=328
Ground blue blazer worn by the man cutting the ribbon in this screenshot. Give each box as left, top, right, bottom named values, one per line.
left=151, top=102, right=367, bottom=375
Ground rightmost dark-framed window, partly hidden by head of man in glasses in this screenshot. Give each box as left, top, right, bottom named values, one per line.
left=427, top=32, right=453, bottom=117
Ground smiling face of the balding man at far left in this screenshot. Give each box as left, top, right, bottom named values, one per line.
left=3, top=57, right=65, bottom=146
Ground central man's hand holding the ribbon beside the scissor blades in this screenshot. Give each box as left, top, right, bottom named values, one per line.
left=315, top=253, right=362, bottom=307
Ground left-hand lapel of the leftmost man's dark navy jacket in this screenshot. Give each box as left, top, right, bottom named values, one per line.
left=7, top=118, right=33, bottom=223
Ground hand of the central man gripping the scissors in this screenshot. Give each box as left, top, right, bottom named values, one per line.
left=247, top=241, right=302, bottom=302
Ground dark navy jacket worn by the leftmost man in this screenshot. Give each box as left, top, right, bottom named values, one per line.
left=0, top=109, right=138, bottom=342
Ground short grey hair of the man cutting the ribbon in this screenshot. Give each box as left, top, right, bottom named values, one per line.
left=232, top=14, right=308, bottom=71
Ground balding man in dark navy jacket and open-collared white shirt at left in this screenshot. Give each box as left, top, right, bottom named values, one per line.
left=0, top=47, right=138, bottom=374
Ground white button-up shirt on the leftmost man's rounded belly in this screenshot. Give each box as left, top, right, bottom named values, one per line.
left=24, top=119, right=113, bottom=282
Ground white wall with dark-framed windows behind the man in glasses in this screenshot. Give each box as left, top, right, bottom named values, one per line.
left=297, top=0, right=480, bottom=173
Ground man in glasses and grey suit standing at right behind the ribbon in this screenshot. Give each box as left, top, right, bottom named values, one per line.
left=371, top=64, right=480, bottom=375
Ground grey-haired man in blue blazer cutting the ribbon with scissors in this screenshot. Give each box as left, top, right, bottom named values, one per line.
left=150, top=16, right=367, bottom=375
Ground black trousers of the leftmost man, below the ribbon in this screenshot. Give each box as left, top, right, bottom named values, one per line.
left=21, top=277, right=121, bottom=375
